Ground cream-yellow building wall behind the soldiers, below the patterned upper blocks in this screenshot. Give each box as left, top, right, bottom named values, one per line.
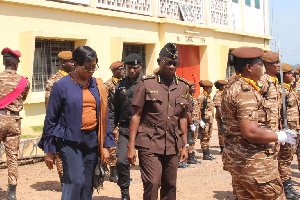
left=0, top=0, right=270, bottom=127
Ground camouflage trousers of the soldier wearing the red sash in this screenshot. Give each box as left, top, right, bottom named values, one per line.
left=0, top=114, right=21, bottom=185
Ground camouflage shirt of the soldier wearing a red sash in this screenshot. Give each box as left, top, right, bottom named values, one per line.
left=0, top=70, right=30, bottom=112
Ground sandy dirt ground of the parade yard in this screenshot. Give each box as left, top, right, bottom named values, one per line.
left=0, top=124, right=300, bottom=200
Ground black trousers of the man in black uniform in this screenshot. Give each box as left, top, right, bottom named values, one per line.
left=117, top=127, right=130, bottom=189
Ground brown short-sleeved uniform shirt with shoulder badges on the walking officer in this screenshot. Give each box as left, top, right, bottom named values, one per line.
left=132, top=74, right=192, bottom=155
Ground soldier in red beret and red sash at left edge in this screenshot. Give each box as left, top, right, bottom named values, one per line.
left=0, top=47, right=30, bottom=200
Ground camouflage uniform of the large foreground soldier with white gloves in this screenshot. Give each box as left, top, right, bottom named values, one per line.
left=221, top=76, right=285, bottom=199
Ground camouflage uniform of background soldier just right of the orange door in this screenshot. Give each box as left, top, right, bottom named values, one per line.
left=197, top=91, right=214, bottom=150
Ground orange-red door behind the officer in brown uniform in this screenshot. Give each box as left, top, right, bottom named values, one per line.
left=176, top=44, right=200, bottom=98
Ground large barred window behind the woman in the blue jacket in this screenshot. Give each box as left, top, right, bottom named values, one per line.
left=32, top=39, right=75, bottom=92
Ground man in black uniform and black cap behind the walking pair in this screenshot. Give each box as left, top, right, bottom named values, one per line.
left=110, top=54, right=142, bottom=200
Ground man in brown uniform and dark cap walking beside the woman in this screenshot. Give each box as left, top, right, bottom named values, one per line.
left=127, top=43, right=192, bottom=200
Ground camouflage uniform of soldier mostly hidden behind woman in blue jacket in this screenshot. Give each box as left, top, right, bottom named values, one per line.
left=45, top=70, right=64, bottom=177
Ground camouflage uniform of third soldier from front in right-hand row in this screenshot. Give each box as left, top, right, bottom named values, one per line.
left=278, top=84, right=300, bottom=182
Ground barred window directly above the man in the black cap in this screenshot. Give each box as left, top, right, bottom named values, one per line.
left=122, top=43, right=146, bottom=75
